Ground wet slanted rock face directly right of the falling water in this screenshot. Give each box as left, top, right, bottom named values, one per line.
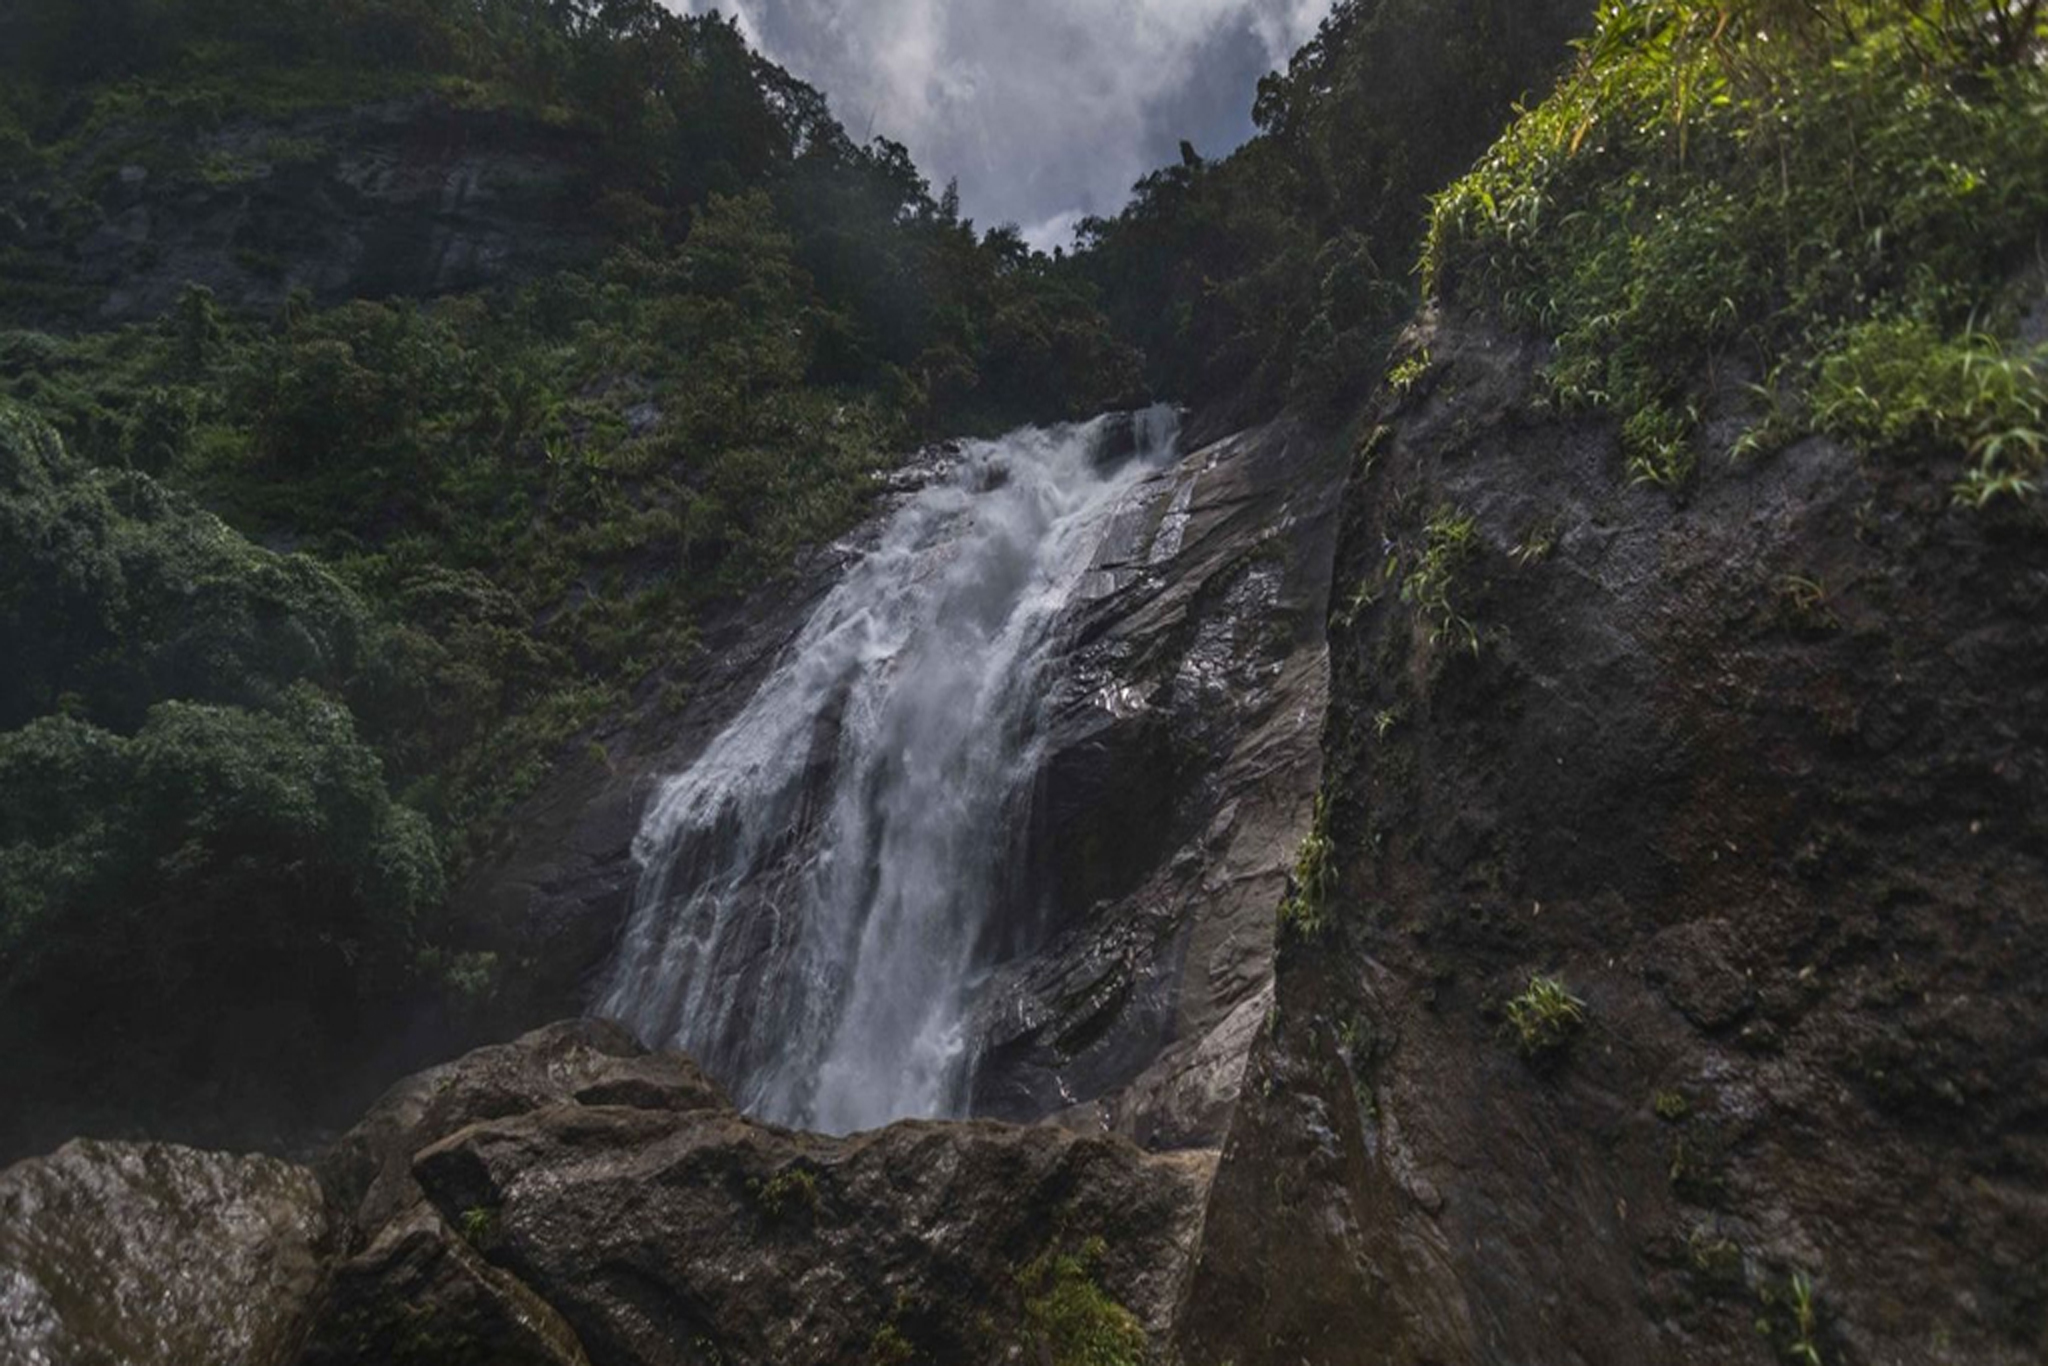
left=975, top=424, right=1343, bottom=1149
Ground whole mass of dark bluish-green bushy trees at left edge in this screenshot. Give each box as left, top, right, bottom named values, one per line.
left=0, top=405, right=442, bottom=1130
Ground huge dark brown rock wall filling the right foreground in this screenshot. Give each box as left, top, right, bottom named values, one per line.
left=1182, top=309, right=2048, bottom=1366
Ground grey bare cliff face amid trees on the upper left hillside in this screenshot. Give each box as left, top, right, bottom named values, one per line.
left=18, top=94, right=602, bottom=324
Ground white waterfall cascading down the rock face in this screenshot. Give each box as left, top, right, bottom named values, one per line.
left=596, top=410, right=1178, bottom=1133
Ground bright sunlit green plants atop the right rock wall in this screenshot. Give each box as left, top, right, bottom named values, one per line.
left=1425, top=0, right=2048, bottom=497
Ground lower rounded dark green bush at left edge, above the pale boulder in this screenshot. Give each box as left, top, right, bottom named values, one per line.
left=0, top=684, right=442, bottom=1110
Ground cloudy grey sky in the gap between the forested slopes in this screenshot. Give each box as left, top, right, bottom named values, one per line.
left=670, top=0, right=1331, bottom=248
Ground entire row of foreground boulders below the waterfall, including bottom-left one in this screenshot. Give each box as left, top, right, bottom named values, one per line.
left=0, top=1020, right=1210, bottom=1366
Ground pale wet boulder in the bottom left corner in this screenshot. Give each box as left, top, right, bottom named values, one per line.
left=0, top=1141, right=332, bottom=1366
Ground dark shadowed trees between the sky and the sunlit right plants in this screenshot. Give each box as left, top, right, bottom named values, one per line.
left=1081, top=0, right=1591, bottom=412
